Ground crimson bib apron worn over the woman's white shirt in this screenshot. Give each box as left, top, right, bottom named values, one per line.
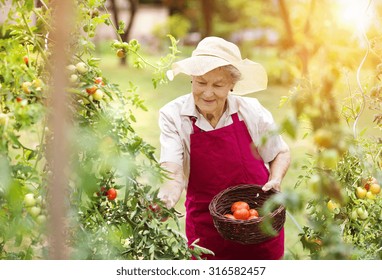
left=185, top=113, right=284, bottom=260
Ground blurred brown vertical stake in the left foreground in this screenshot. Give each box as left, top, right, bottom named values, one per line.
left=47, top=0, right=75, bottom=260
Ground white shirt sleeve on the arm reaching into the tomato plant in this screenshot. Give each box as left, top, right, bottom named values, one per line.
left=159, top=107, right=183, bottom=166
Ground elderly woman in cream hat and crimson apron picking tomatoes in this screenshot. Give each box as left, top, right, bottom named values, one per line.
left=159, top=37, right=290, bottom=259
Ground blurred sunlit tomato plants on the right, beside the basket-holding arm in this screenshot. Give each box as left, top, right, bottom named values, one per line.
left=279, top=1, right=382, bottom=259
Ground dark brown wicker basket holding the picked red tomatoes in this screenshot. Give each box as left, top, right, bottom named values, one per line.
left=209, top=185, right=285, bottom=244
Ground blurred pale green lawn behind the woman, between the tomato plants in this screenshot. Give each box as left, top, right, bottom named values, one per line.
left=100, top=43, right=375, bottom=259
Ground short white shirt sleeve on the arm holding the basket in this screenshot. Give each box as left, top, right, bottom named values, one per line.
left=242, top=99, right=289, bottom=163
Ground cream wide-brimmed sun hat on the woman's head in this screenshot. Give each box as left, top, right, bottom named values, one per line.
left=167, top=37, right=268, bottom=95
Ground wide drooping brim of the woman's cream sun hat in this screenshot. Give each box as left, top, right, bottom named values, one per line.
left=167, top=55, right=268, bottom=95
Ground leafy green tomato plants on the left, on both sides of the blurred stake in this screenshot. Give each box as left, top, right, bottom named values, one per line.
left=0, top=0, right=208, bottom=259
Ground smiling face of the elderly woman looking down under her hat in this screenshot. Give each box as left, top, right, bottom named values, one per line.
left=192, top=68, right=234, bottom=117
